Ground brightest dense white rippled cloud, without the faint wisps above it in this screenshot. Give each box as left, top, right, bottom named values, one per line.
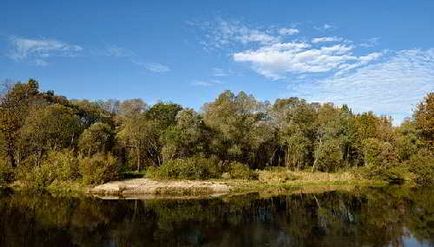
left=233, top=42, right=379, bottom=80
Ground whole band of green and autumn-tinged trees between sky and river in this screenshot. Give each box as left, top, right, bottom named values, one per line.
left=0, top=79, right=434, bottom=188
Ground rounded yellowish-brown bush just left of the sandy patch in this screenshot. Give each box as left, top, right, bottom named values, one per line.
left=79, top=153, right=120, bottom=184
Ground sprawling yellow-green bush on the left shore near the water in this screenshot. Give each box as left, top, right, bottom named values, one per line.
left=18, top=150, right=80, bottom=189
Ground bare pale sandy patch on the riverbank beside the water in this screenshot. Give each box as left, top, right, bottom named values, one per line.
left=88, top=178, right=230, bottom=198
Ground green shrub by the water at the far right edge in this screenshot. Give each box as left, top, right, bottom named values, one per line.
left=407, top=151, right=434, bottom=185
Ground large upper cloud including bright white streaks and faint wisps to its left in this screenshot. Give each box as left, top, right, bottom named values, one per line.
left=196, top=19, right=382, bottom=80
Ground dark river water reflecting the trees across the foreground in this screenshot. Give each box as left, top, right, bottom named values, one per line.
left=0, top=188, right=434, bottom=247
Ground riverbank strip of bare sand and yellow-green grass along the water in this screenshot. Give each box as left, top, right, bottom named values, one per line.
left=87, top=170, right=384, bottom=199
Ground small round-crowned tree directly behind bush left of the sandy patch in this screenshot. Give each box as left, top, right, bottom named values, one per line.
left=78, top=122, right=114, bottom=156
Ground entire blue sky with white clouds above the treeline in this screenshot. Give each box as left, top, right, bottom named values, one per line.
left=0, top=0, right=434, bottom=123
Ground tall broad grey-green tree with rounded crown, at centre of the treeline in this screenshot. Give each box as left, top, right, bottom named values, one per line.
left=203, top=91, right=271, bottom=166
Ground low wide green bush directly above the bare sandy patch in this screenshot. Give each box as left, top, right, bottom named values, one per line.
left=146, top=156, right=221, bottom=179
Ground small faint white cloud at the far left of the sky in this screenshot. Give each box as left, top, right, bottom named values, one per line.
left=9, top=37, right=83, bottom=65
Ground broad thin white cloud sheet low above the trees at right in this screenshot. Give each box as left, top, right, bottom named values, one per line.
left=289, top=49, right=434, bottom=123
